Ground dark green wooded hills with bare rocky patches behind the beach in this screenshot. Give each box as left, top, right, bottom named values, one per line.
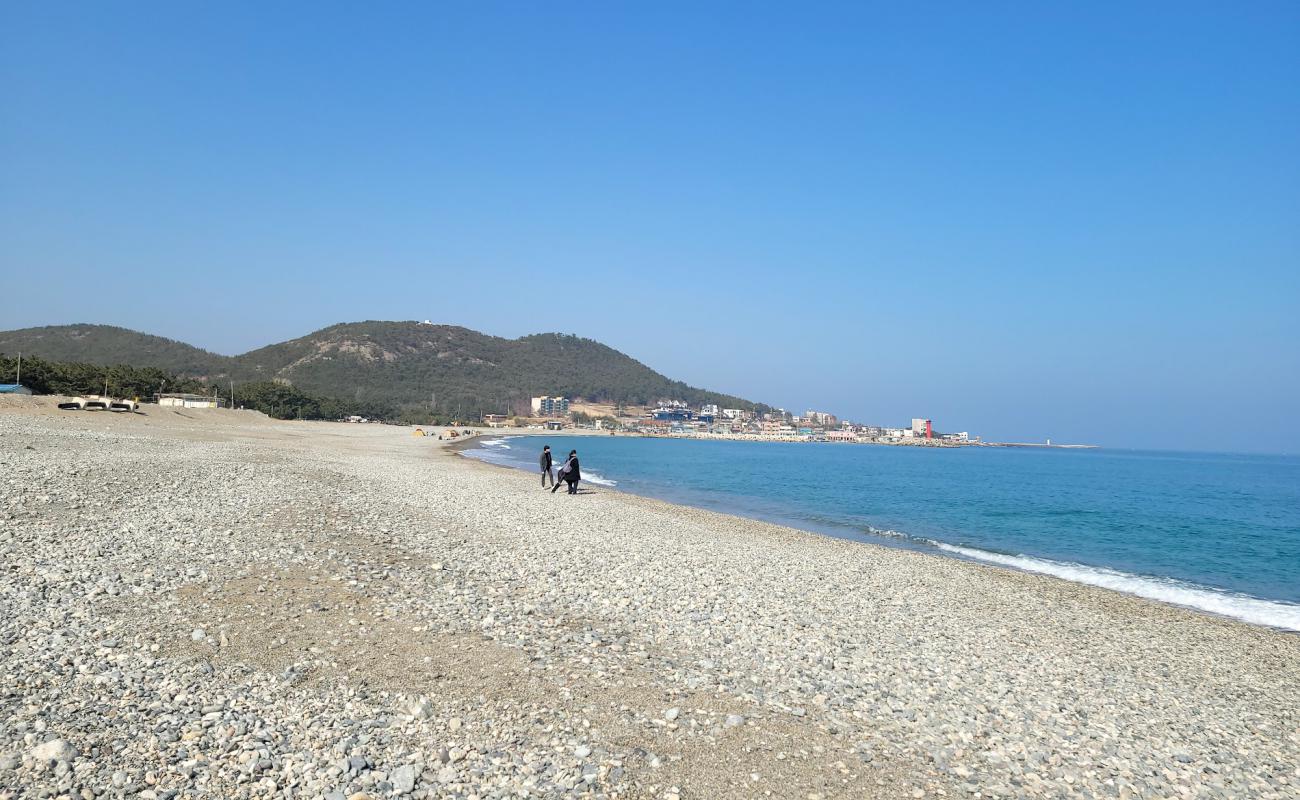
left=0, top=320, right=766, bottom=412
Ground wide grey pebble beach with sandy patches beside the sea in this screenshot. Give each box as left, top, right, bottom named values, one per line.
left=0, top=398, right=1300, bottom=800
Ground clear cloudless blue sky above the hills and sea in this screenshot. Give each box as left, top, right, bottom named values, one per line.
left=0, top=1, right=1300, bottom=453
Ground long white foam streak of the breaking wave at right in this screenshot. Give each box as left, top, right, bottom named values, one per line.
left=927, top=540, right=1300, bottom=631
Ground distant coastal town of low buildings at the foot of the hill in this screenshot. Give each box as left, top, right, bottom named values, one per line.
left=482, top=395, right=977, bottom=447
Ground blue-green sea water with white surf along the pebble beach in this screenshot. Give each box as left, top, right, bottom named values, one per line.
left=465, top=436, right=1300, bottom=631
